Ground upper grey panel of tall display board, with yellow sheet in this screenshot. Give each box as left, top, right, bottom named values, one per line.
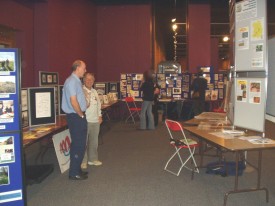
left=235, top=0, right=267, bottom=72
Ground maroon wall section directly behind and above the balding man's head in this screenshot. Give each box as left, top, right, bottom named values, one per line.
left=35, top=0, right=96, bottom=84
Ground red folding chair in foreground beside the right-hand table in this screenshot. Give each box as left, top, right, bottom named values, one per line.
left=164, top=119, right=199, bottom=177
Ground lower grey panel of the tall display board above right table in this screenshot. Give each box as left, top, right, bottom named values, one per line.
left=234, top=75, right=266, bottom=132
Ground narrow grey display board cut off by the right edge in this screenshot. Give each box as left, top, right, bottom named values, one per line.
left=266, top=38, right=275, bottom=122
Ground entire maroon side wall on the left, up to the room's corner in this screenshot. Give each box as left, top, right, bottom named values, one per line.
left=0, top=0, right=97, bottom=87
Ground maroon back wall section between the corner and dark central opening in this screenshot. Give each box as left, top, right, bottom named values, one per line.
left=96, top=5, right=152, bottom=81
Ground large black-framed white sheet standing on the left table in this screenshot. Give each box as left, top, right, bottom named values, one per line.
left=28, top=87, right=56, bottom=126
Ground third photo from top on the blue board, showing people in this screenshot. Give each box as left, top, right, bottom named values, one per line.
left=0, top=100, right=14, bottom=123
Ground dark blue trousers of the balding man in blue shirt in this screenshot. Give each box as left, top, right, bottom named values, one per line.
left=66, top=113, right=87, bottom=176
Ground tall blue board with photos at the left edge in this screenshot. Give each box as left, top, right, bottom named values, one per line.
left=0, top=48, right=26, bottom=206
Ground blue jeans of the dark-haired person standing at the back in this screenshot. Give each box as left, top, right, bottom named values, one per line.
left=140, top=101, right=155, bottom=129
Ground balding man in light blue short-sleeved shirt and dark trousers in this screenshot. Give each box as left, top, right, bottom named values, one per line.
left=62, top=60, right=88, bottom=180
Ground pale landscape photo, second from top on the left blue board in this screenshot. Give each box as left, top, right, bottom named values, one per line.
left=0, top=76, right=16, bottom=97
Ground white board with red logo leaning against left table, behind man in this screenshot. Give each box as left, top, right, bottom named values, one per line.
left=52, top=129, right=71, bottom=173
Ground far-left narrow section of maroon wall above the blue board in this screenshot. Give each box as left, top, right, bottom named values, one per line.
left=0, top=0, right=35, bottom=87
